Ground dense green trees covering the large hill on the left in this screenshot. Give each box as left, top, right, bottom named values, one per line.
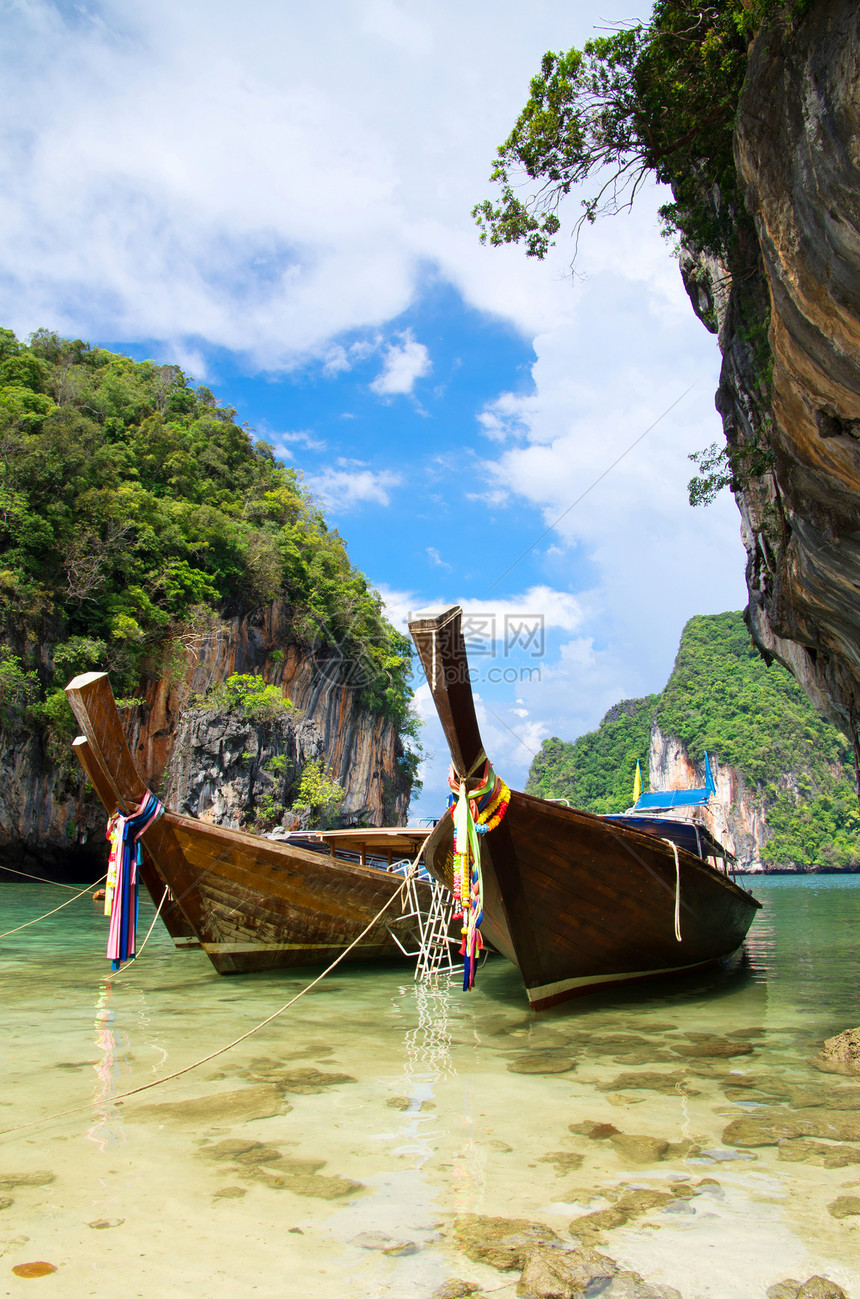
left=0, top=330, right=412, bottom=774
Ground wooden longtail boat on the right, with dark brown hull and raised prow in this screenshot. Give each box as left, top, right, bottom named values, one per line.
left=409, top=608, right=760, bottom=1009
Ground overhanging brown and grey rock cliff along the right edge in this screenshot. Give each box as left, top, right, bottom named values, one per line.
left=682, top=0, right=860, bottom=737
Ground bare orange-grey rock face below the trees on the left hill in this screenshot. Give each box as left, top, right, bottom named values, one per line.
left=0, top=601, right=411, bottom=879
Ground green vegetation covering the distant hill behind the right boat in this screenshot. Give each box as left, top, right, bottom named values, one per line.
left=526, top=613, right=860, bottom=869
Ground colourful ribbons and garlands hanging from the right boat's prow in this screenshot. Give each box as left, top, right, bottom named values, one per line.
left=448, top=757, right=511, bottom=992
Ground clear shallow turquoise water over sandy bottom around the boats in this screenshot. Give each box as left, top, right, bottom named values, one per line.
left=0, top=876, right=860, bottom=1299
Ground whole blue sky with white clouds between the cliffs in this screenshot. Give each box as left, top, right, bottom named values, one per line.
left=0, top=0, right=744, bottom=814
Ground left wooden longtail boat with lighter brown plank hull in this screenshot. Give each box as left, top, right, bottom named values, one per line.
left=66, top=672, right=433, bottom=974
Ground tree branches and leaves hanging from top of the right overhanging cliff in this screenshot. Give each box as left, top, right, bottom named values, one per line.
left=473, top=0, right=807, bottom=257
